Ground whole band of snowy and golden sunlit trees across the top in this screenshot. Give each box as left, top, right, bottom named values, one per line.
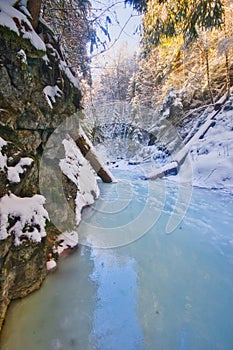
left=24, top=0, right=233, bottom=121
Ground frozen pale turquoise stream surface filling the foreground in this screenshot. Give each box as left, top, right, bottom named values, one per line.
left=0, top=168, right=233, bottom=350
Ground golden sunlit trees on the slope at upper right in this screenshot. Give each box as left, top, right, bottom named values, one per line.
left=130, top=0, right=233, bottom=105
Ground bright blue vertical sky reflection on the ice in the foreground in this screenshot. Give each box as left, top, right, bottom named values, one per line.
left=90, top=250, right=143, bottom=350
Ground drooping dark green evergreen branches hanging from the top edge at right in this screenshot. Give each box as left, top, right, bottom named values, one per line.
left=143, top=0, right=224, bottom=50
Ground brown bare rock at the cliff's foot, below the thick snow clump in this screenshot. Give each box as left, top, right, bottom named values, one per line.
left=0, top=236, right=46, bottom=326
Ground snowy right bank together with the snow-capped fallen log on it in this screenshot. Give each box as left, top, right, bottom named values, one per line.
left=146, top=95, right=233, bottom=192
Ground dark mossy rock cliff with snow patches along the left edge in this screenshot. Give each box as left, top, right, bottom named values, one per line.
left=0, top=1, right=97, bottom=329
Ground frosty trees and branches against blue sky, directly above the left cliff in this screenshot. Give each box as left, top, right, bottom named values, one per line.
left=26, top=0, right=118, bottom=78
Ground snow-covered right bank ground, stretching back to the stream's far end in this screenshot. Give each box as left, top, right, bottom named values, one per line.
left=107, top=99, right=233, bottom=193
